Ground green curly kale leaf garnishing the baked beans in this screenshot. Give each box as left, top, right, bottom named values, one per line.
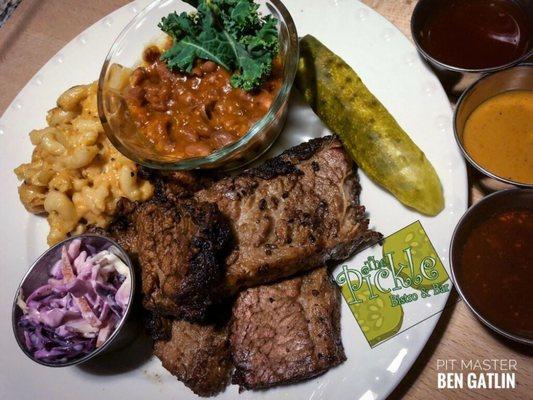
left=158, top=0, right=279, bottom=91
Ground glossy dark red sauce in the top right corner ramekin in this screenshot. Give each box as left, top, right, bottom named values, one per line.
left=419, top=0, right=533, bottom=69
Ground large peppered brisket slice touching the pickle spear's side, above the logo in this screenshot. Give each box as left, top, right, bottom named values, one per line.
left=195, top=136, right=379, bottom=294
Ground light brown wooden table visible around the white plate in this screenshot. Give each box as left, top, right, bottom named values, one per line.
left=0, top=0, right=533, bottom=400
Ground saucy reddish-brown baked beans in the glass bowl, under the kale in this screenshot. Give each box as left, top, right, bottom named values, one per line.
left=124, top=47, right=283, bottom=159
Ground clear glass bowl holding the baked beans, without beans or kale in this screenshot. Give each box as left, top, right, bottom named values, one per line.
left=98, top=0, right=298, bottom=170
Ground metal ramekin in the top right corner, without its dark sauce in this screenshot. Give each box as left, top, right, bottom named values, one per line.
left=411, top=0, right=533, bottom=98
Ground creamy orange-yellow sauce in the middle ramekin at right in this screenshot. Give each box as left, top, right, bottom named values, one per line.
left=463, top=90, right=533, bottom=183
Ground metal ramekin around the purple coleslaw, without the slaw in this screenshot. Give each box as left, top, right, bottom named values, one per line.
left=11, top=234, right=137, bottom=367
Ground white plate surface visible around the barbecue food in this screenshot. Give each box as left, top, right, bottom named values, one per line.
left=0, top=0, right=467, bottom=400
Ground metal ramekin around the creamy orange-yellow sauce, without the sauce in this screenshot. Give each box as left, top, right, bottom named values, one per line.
left=453, top=64, right=533, bottom=188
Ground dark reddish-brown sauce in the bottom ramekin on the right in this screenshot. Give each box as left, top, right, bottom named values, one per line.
left=457, top=210, right=533, bottom=338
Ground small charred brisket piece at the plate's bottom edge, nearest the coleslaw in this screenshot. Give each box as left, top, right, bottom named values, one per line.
left=154, top=320, right=233, bottom=396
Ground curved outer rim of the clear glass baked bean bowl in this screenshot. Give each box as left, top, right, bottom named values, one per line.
left=97, top=0, right=299, bottom=170
